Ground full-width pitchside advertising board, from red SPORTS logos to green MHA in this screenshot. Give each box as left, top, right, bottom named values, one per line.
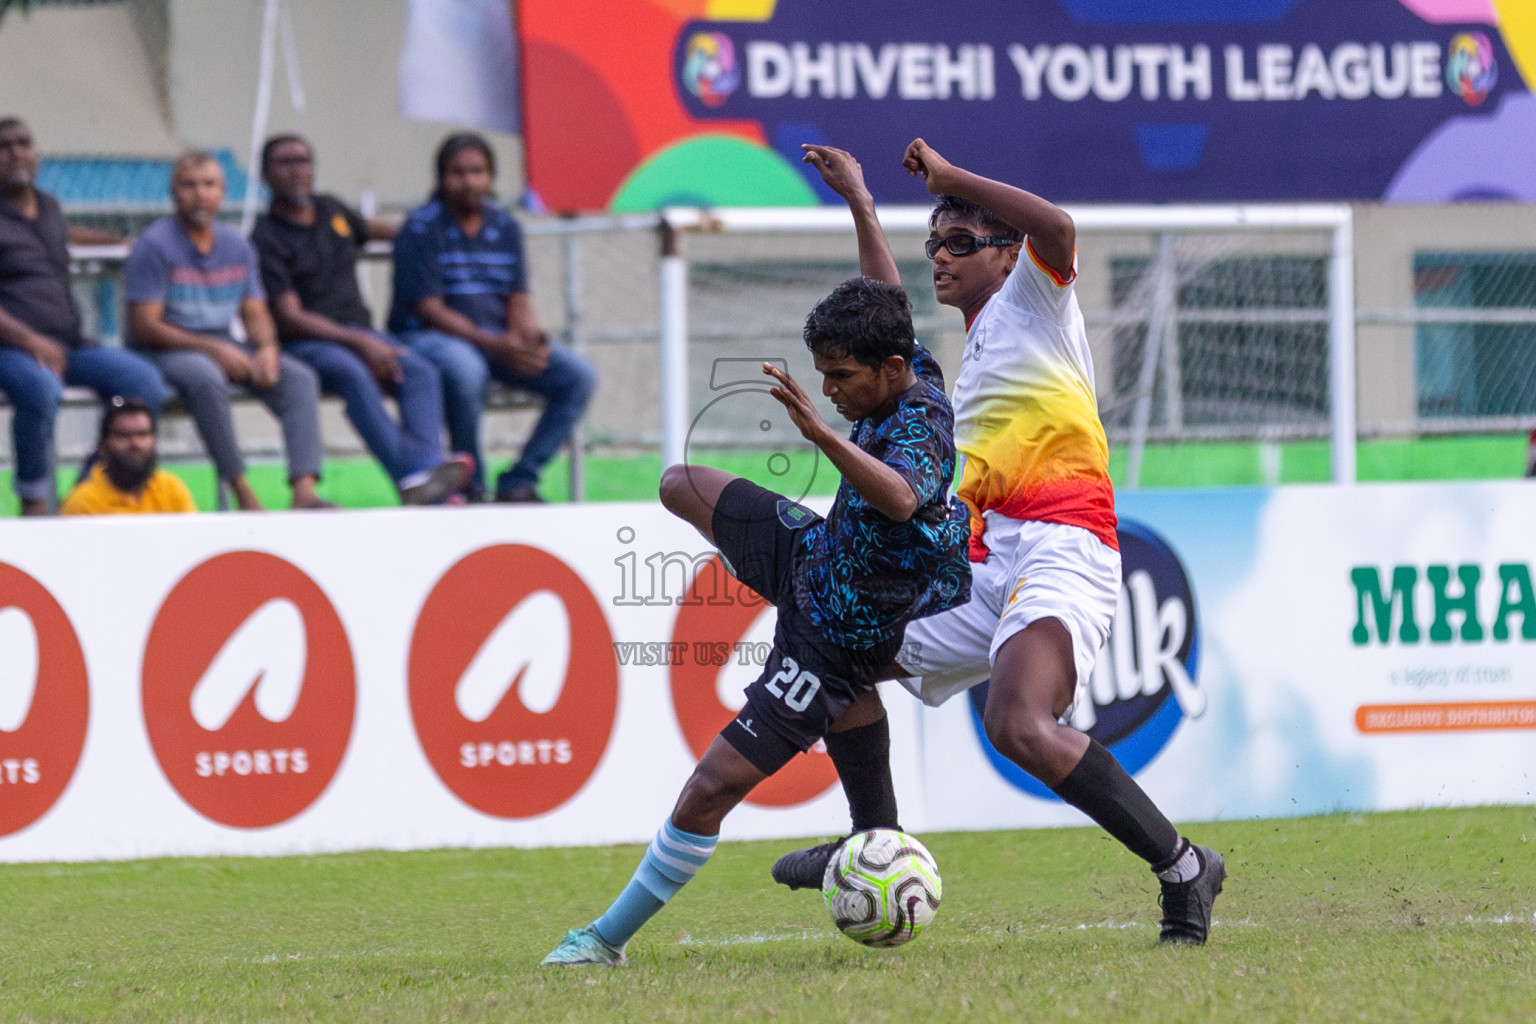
left=0, top=481, right=1536, bottom=861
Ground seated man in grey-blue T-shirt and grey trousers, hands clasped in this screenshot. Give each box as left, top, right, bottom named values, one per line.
left=123, top=152, right=330, bottom=510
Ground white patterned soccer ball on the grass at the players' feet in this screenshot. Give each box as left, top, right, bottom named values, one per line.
left=822, top=829, right=945, bottom=946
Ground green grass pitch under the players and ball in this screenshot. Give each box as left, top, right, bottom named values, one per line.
left=0, top=808, right=1536, bottom=1024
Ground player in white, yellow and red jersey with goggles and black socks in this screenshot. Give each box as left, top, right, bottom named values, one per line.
left=773, top=138, right=1226, bottom=944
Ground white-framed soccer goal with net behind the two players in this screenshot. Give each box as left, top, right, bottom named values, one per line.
left=660, top=206, right=1355, bottom=487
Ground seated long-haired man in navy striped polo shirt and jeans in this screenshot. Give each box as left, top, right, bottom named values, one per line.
left=389, top=132, right=598, bottom=502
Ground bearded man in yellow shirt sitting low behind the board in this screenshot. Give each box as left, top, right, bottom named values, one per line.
left=60, top=398, right=197, bottom=516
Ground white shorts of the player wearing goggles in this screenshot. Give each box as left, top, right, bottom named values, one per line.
left=897, top=513, right=1120, bottom=714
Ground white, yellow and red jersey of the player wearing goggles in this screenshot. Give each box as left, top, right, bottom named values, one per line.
left=954, top=238, right=1120, bottom=560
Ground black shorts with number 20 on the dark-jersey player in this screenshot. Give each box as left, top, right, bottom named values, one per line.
left=711, top=479, right=902, bottom=775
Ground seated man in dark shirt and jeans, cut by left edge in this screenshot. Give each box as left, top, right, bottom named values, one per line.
left=0, top=117, right=169, bottom=516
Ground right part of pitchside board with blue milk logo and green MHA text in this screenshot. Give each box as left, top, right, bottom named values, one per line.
left=915, top=481, right=1536, bottom=829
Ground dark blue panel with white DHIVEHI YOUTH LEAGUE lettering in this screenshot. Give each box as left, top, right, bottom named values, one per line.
left=677, top=0, right=1528, bottom=201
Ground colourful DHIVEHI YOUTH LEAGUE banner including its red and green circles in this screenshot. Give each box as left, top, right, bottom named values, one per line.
left=518, top=0, right=1536, bottom=210
